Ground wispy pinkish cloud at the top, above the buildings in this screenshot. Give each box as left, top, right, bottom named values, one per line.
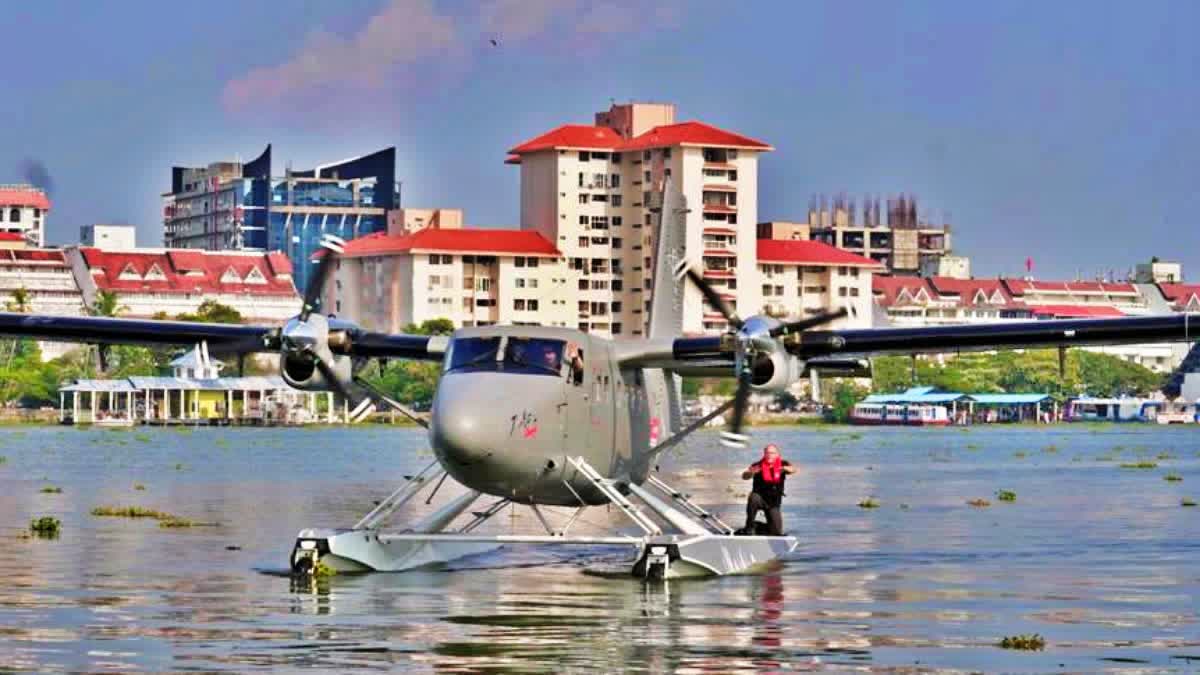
left=221, top=0, right=677, bottom=114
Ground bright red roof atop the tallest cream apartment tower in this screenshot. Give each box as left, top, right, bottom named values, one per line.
left=504, top=121, right=774, bottom=154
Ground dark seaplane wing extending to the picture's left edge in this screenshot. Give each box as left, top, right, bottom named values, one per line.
left=0, top=312, right=448, bottom=360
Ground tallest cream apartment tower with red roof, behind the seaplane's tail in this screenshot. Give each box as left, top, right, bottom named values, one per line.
left=506, top=103, right=772, bottom=336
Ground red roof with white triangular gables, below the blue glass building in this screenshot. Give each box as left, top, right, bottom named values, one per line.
left=80, top=247, right=296, bottom=295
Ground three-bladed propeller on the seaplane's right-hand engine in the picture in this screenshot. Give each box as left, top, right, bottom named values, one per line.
left=676, top=261, right=846, bottom=448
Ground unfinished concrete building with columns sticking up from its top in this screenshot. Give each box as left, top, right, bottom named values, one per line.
left=787, top=193, right=952, bottom=274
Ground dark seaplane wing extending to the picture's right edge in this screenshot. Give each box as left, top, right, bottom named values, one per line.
left=658, top=313, right=1200, bottom=365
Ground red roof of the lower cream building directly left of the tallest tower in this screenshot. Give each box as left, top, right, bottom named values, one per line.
left=343, top=227, right=562, bottom=257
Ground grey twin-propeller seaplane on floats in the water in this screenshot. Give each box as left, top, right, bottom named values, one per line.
left=0, top=183, right=1200, bottom=580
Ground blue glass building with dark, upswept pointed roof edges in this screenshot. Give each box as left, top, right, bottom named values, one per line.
left=163, top=145, right=400, bottom=292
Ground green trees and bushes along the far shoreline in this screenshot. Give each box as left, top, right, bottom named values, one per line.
left=0, top=305, right=1165, bottom=426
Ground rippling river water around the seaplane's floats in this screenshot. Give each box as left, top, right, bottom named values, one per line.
left=0, top=425, right=1200, bottom=673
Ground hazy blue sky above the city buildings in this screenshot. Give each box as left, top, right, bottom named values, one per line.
left=0, top=0, right=1200, bottom=280
